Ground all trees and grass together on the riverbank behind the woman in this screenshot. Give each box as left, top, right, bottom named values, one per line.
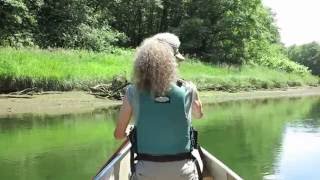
left=0, top=0, right=319, bottom=92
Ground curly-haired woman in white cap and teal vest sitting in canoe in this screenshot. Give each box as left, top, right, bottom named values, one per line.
left=114, top=33, right=202, bottom=180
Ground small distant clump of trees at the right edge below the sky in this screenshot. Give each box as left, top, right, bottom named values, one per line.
left=288, top=42, right=320, bottom=75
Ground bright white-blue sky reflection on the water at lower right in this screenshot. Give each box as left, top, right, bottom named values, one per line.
left=276, top=126, right=320, bottom=180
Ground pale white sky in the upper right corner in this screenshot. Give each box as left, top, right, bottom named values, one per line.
left=262, top=0, right=320, bottom=46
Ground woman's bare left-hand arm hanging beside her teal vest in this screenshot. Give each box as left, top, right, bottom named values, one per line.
left=114, top=96, right=132, bottom=139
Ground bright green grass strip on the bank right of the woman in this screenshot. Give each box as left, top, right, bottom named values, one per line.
left=180, top=61, right=319, bottom=92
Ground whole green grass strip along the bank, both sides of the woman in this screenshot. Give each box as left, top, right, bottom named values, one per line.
left=0, top=48, right=319, bottom=92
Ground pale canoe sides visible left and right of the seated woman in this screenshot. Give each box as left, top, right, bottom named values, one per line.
left=93, top=140, right=242, bottom=180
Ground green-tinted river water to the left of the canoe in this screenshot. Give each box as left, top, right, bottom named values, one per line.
left=0, top=107, right=118, bottom=180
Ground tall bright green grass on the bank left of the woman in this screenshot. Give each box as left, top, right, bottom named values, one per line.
left=0, top=48, right=133, bottom=92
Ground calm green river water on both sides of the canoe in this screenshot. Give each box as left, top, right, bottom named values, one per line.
left=0, top=97, right=320, bottom=180
